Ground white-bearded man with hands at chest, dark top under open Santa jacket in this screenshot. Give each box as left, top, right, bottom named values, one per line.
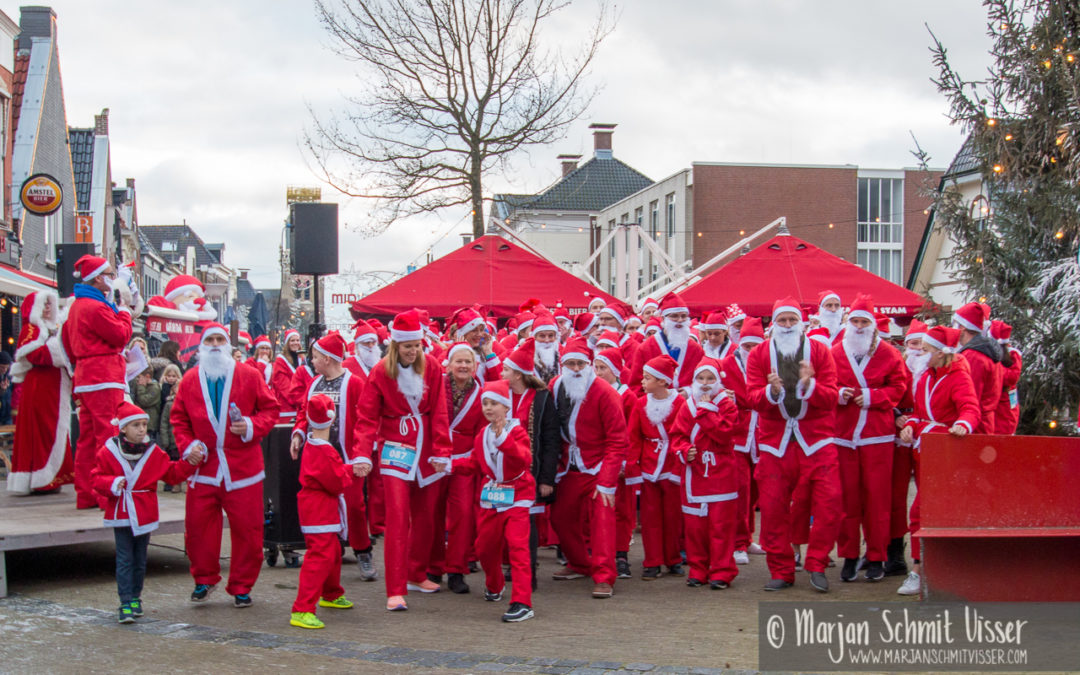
left=746, top=298, right=842, bottom=593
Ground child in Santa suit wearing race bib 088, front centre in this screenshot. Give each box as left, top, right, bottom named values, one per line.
left=461, top=381, right=536, bottom=622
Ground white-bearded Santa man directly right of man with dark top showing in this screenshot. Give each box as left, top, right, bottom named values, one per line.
left=833, top=295, right=907, bottom=581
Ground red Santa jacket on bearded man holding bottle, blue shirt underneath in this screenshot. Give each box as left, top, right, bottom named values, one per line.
left=168, top=364, right=278, bottom=491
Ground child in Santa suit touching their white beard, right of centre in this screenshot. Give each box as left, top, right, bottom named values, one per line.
left=626, top=355, right=686, bottom=581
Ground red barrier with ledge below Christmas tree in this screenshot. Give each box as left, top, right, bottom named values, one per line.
left=917, top=434, right=1080, bottom=602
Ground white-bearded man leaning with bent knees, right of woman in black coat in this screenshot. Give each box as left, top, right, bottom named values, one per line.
left=551, top=337, right=629, bottom=598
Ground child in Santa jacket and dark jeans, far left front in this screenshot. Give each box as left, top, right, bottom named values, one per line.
left=91, top=403, right=203, bottom=623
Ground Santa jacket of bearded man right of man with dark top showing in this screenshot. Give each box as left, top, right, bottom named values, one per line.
left=833, top=339, right=907, bottom=448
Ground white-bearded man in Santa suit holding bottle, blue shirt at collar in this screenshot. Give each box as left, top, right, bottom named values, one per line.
left=170, top=323, right=278, bottom=608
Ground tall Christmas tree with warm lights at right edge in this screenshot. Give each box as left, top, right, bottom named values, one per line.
left=931, top=0, right=1080, bottom=434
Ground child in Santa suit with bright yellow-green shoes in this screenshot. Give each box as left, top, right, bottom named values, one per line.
left=288, top=393, right=359, bottom=629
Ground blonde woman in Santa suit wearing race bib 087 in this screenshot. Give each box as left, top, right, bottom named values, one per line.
left=354, top=310, right=454, bottom=611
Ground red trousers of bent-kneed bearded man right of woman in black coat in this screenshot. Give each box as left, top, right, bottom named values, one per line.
left=551, top=471, right=617, bottom=585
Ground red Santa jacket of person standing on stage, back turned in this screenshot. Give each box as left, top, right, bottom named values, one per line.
left=60, top=284, right=132, bottom=394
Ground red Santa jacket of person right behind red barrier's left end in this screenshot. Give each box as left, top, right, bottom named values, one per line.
left=905, top=355, right=982, bottom=448
